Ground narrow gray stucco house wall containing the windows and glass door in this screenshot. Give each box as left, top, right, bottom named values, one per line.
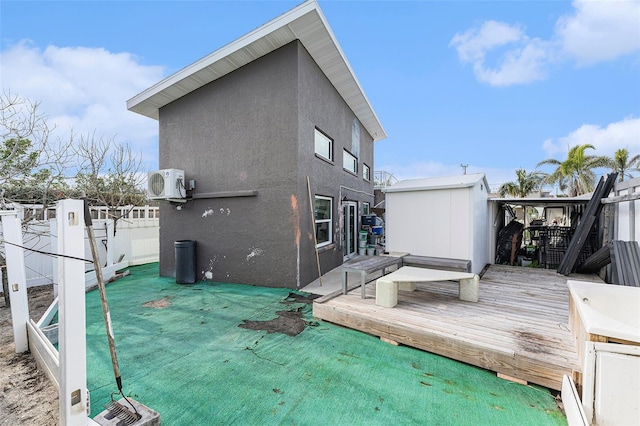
left=298, top=44, right=373, bottom=282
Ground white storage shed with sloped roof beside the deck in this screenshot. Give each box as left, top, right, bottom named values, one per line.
left=384, top=174, right=489, bottom=273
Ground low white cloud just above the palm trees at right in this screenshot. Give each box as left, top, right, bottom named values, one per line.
left=542, top=118, right=640, bottom=160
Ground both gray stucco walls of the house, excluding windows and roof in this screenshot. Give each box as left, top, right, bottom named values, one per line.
left=160, top=41, right=373, bottom=288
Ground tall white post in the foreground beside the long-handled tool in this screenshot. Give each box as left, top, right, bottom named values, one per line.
left=56, top=200, right=88, bottom=426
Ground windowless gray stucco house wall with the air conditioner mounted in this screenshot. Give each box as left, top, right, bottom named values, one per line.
left=160, top=44, right=298, bottom=287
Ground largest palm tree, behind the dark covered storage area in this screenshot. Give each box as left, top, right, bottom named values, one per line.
left=536, top=144, right=610, bottom=197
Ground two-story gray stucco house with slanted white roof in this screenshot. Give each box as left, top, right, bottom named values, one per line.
left=127, top=1, right=386, bottom=288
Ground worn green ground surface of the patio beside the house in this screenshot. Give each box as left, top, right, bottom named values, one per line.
left=86, top=264, right=566, bottom=425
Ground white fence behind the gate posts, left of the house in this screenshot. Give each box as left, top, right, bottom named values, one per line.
left=0, top=206, right=160, bottom=287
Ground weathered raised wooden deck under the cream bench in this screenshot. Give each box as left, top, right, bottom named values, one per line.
left=313, top=265, right=601, bottom=390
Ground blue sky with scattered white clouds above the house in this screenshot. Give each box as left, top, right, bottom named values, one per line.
left=0, top=0, right=640, bottom=190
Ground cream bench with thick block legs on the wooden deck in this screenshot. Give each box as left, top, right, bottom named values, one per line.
left=376, top=266, right=480, bottom=308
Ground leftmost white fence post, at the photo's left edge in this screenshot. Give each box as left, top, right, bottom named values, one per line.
left=0, top=210, right=29, bottom=353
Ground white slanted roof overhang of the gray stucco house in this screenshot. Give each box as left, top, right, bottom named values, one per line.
left=127, top=0, right=387, bottom=141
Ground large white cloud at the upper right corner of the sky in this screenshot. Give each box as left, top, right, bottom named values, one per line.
left=449, top=0, right=640, bottom=86
